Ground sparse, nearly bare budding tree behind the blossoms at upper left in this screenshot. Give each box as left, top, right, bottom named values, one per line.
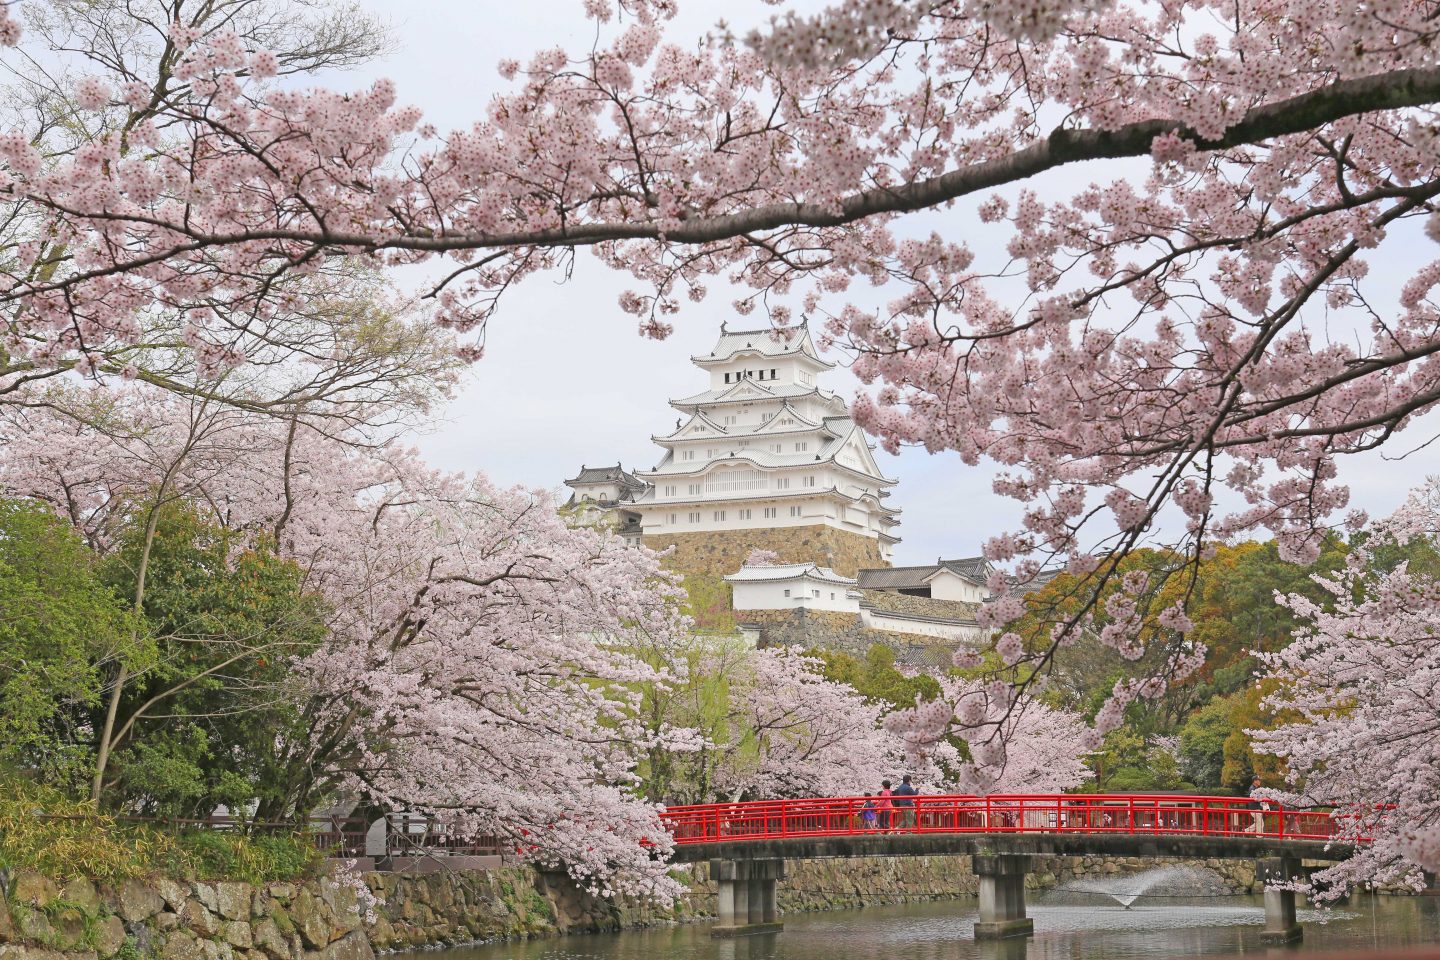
left=0, top=0, right=455, bottom=422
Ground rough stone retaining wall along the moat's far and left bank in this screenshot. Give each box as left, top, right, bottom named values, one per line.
left=0, top=856, right=1405, bottom=960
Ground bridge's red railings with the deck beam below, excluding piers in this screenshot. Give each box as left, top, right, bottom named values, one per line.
left=664, top=794, right=1351, bottom=862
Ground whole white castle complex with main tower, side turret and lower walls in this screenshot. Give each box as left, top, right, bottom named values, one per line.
left=566, top=325, right=991, bottom=645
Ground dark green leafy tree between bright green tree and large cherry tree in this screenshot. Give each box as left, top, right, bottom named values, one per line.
left=105, top=502, right=325, bottom=816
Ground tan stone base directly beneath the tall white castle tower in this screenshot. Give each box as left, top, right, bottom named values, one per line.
left=641, top=524, right=890, bottom=577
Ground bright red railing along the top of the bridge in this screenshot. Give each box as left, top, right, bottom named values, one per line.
left=664, top=793, right=1341, bottom=843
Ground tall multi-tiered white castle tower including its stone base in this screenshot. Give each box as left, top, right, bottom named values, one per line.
left=631, top=327, right=900, bottom=576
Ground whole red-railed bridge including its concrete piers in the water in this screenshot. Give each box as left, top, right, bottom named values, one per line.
left=664, top=793, right=1351, bottom=943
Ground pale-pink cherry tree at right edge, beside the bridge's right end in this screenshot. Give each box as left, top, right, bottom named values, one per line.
left=1251, top=479, right=1440, bottom=897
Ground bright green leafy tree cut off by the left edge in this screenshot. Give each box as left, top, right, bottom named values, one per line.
left=0, top=499, right=135, bottom=789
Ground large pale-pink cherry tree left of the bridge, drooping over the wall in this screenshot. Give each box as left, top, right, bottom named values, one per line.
left=0, top=389, right=685, bottom=895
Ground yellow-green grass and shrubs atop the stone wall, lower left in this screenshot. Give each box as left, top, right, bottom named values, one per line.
left=0, top=776, right=321, bottom=884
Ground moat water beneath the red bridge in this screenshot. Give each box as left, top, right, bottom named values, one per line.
left=397, top=892, right=1440, bottom=960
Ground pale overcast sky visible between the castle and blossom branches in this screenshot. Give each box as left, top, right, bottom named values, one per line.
left=325, top=0, right=1440, bottom=563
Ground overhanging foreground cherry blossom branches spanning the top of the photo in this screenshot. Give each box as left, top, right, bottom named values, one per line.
left=0, top=0, right=1440, bottom=697
